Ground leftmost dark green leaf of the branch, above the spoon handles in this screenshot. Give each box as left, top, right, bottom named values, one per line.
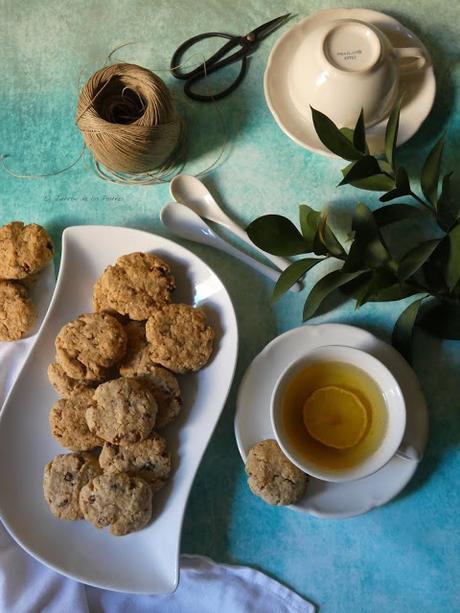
left=246, top=215, right=310, bottom=256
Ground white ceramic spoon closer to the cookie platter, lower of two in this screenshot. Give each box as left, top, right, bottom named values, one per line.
left=160, top=202, right=302, bottom=292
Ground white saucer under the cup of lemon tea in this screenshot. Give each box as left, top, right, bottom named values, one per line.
left=235, top=324, right=428, bottom=519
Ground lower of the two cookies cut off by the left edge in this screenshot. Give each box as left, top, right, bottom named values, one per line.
left=0, top=280, right=37, bottom=341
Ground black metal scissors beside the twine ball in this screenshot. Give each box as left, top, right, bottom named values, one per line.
left=170, top=13, right=291, bottom=102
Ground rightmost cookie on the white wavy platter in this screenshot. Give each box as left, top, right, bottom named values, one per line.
left=145, top=304, right=214, bottom=373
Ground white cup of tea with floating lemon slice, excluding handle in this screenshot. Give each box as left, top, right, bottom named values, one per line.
left=271, top=346, right=406, bottom=481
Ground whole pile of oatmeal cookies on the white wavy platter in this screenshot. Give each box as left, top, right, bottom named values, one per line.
left=43, top=253, right=214, bottom=535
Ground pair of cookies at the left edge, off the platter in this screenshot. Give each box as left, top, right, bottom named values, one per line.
left=0, top=221, right=53, bottom=341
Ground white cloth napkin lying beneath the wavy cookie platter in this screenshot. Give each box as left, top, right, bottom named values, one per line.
left=0, top=267, right=315, bottom=613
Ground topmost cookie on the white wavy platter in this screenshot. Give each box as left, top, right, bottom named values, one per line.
left=93, top=252, right=176, bottom=321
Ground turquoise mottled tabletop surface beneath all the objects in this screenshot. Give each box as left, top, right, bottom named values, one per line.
left=0, top=0, right=460, bottom=613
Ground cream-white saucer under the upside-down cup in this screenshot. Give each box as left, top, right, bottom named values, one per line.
left=264, top=8, right=436, bottom=157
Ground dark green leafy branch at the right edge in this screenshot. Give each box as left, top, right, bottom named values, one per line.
left=247, top=104, right=460, bottom=357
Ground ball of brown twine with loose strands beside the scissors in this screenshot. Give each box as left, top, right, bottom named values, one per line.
left=0, top=43, right=228, bottom=185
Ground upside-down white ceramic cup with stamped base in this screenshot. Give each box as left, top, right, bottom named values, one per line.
left=289, top=19, right=426, bottom=128
